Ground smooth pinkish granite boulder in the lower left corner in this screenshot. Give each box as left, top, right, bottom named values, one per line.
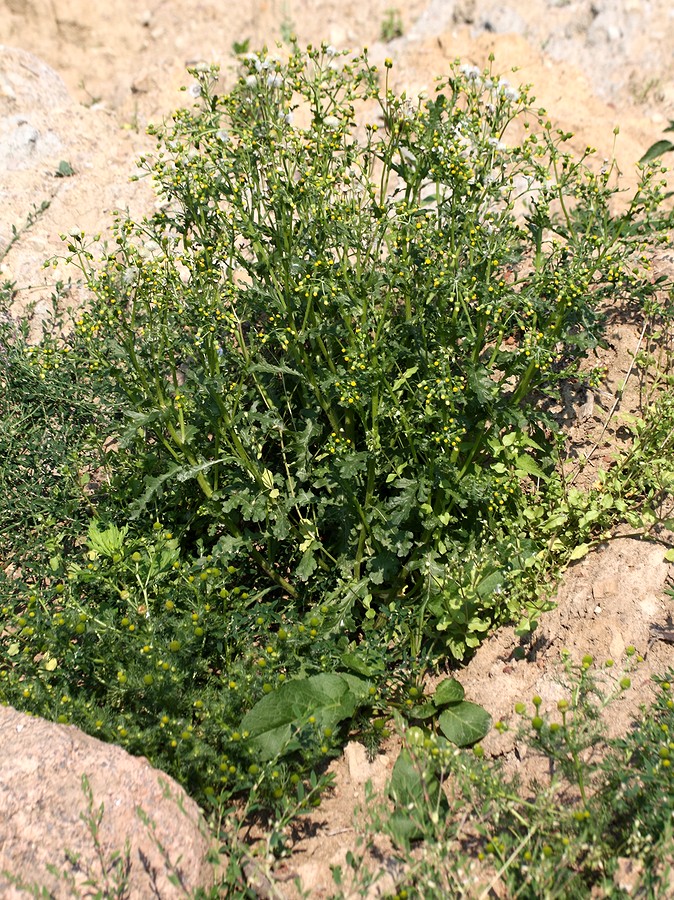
left=0, top=707, right=214, bottom=900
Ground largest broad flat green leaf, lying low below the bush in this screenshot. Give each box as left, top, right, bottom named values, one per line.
left=240, top=672, right=368, bottom=762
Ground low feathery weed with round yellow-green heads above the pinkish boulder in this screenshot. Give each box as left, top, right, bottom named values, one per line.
left=0, top=523, right=368, bottom=807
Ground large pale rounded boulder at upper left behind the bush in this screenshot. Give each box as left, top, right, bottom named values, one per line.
left=0, top=45, right=154, bottom=336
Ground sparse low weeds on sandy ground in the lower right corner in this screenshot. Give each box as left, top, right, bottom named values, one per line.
left=342, top=648, right=674, bottom=898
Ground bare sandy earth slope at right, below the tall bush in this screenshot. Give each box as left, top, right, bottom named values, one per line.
left=460, top=538, right=671, bottom=765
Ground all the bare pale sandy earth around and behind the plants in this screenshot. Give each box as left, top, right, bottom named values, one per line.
left=0, top=0, right=674, bottom=898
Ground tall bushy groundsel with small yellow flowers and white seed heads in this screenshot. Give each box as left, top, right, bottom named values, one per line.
left=69, top=45, right=661, bottom=658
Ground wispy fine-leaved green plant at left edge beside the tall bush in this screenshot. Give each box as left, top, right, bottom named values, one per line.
left=0, top=298, right=114, bottom=572
